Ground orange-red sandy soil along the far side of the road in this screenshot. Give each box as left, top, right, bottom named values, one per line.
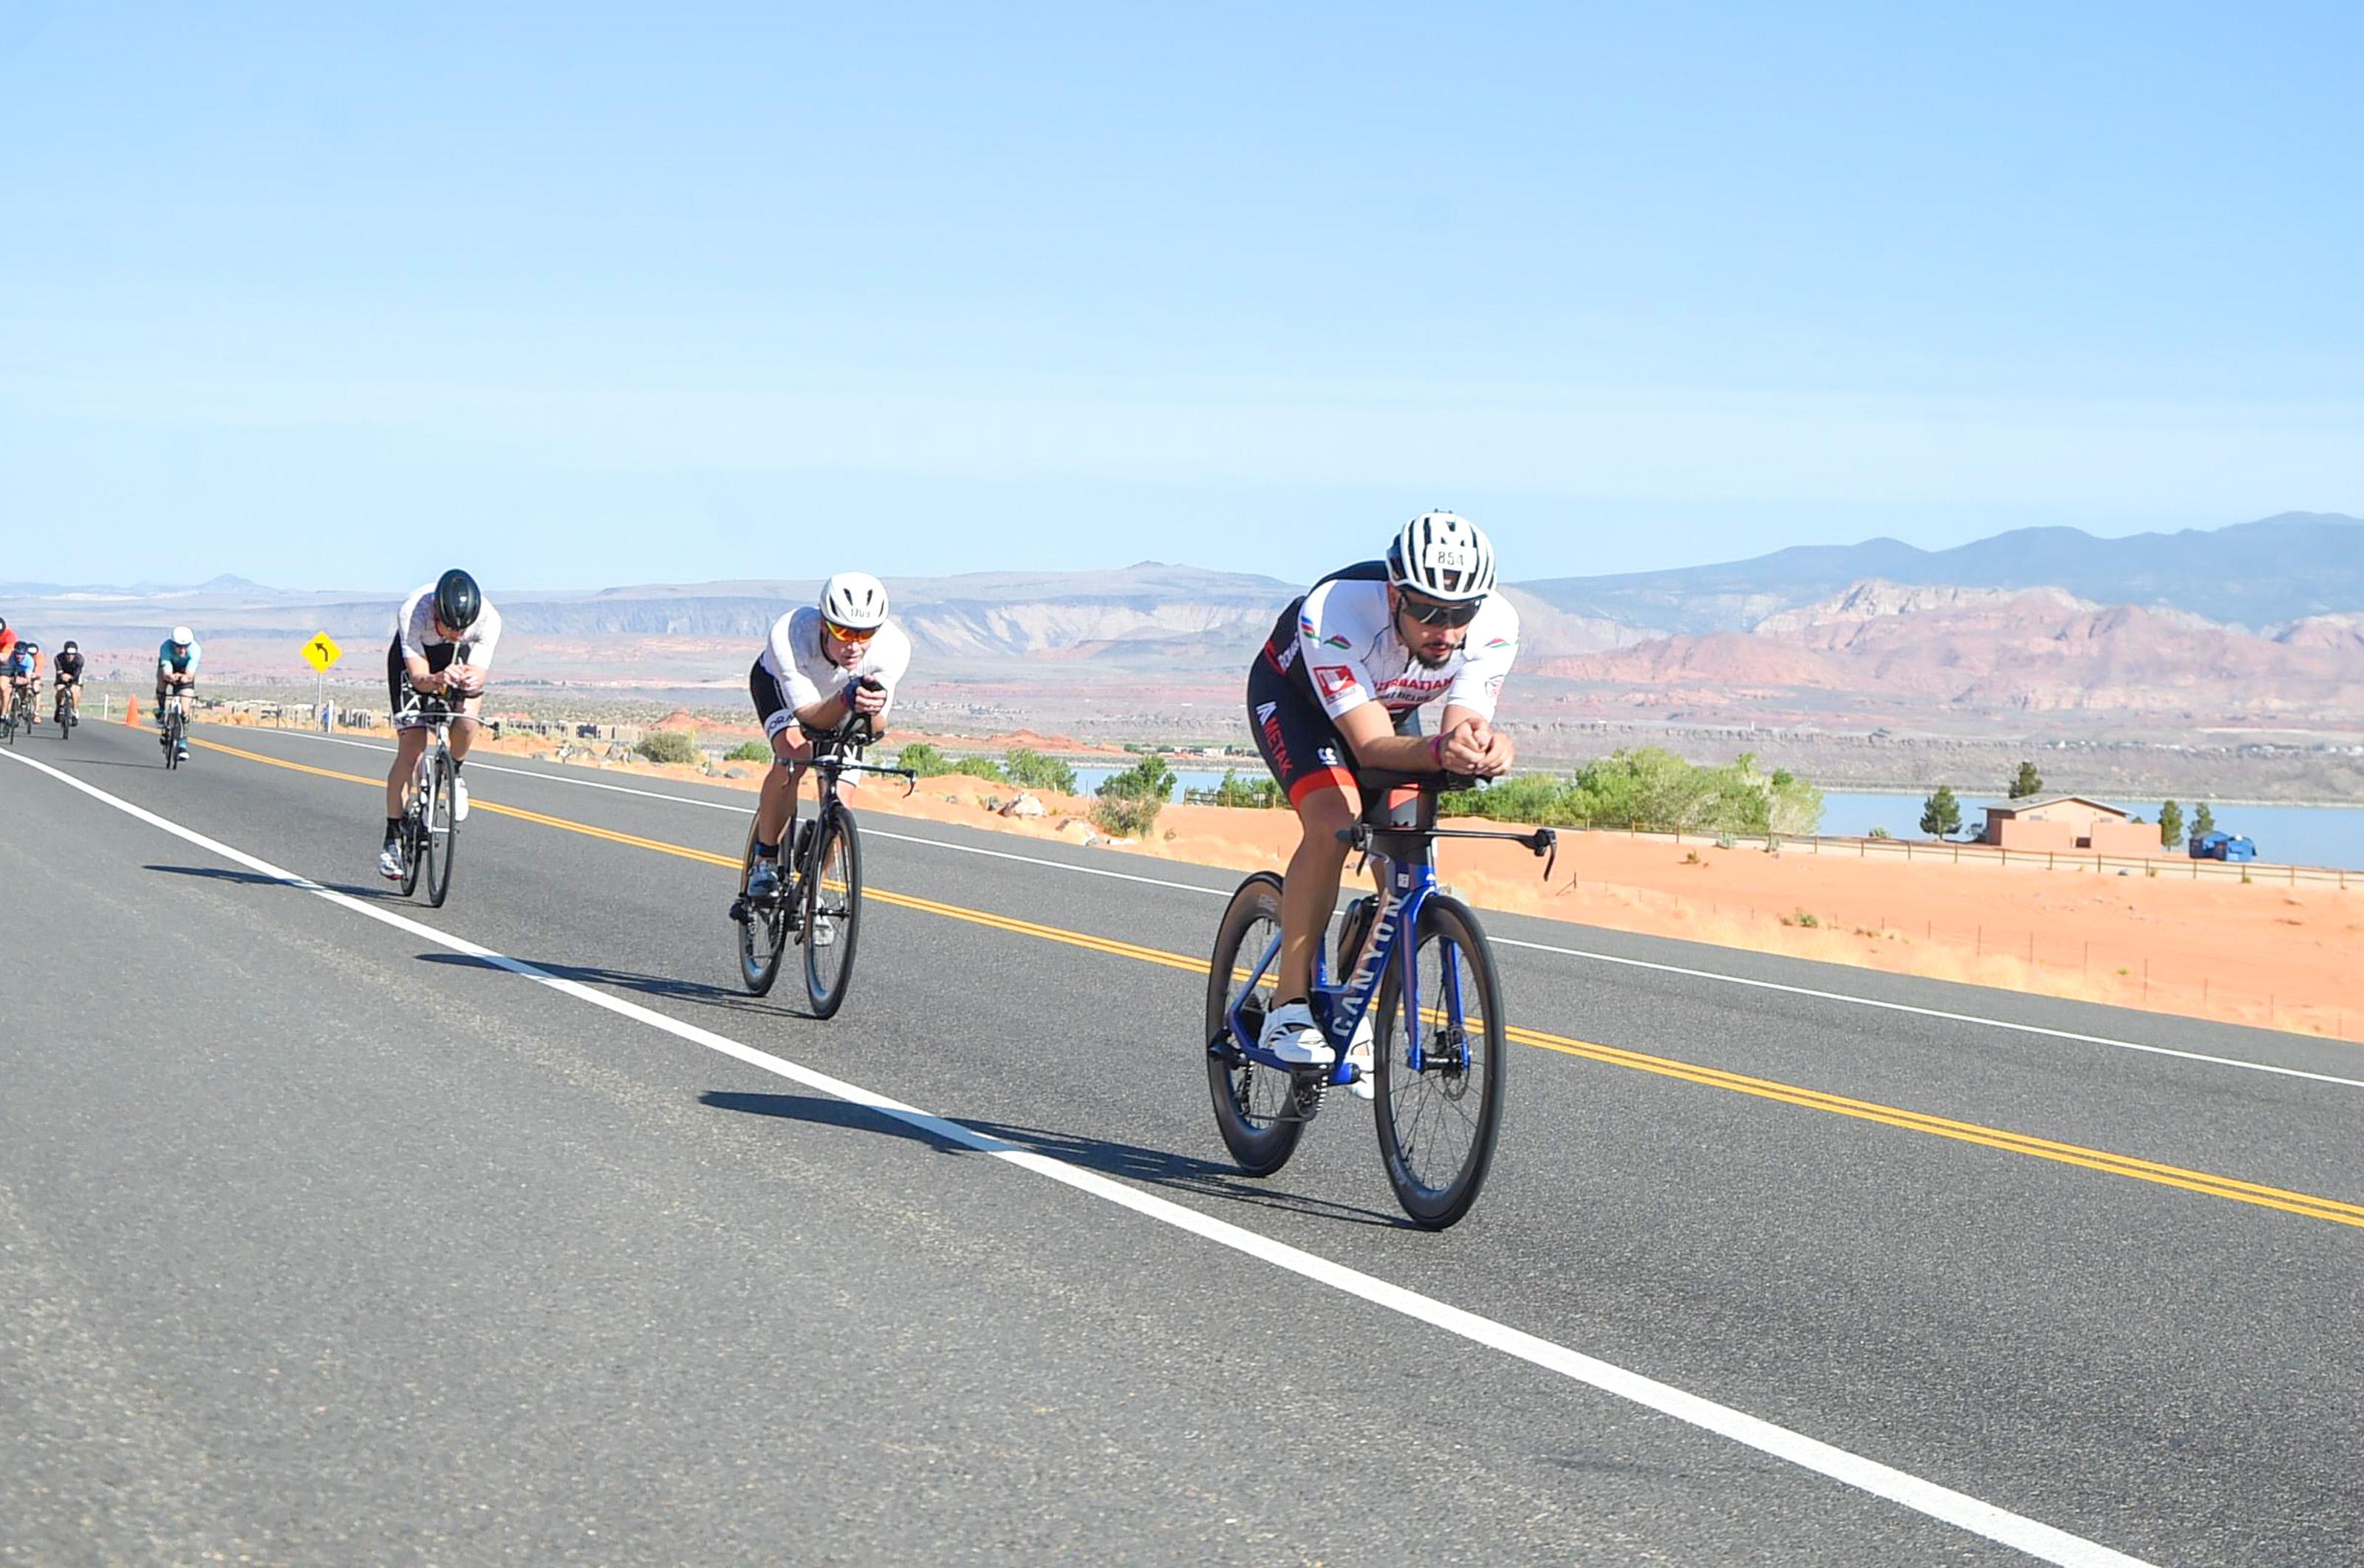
left=440, top=730, right=2364, bottom=1041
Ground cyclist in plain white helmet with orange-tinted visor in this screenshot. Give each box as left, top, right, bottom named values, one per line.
left=747, top=572, right=910, bottom=899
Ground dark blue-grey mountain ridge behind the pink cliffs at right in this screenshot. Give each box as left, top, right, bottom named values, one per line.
left=1523, top=511, right=2364, bottom=634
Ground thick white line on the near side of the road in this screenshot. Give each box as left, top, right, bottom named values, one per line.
left=0, top=752, right=2149, bottom=1568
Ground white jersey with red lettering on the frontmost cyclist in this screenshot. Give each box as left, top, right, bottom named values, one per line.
left=1274, top=568, right=1517, bottom=722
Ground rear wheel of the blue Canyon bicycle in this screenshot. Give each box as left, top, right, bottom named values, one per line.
left=1203, top=870, right=1312, bottom=1175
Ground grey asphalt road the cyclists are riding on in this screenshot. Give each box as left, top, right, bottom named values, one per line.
left=0, top=724, right=2364, bottom=1564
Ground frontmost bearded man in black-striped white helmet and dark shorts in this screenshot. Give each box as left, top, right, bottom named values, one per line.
left=1248, top=511, right=1517, bottom=1100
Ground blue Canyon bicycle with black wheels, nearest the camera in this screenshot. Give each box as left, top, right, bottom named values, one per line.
left=1206, top=769, right=1558, bottom=1230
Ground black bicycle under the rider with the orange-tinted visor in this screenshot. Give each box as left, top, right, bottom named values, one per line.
left=731, top=716, right=920, bottom=1019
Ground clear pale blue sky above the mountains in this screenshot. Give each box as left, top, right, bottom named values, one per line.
left=0, top=0, right=2364, bottom=586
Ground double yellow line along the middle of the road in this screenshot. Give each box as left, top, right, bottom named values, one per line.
left=197, top=740, right=2364, bottom=1228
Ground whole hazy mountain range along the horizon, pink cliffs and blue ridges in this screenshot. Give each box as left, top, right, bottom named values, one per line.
left=13, top=513, right=2364, bottom=730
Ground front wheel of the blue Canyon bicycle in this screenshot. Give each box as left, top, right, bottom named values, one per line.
left=1371, top=894, right=1509, bottom=1230
